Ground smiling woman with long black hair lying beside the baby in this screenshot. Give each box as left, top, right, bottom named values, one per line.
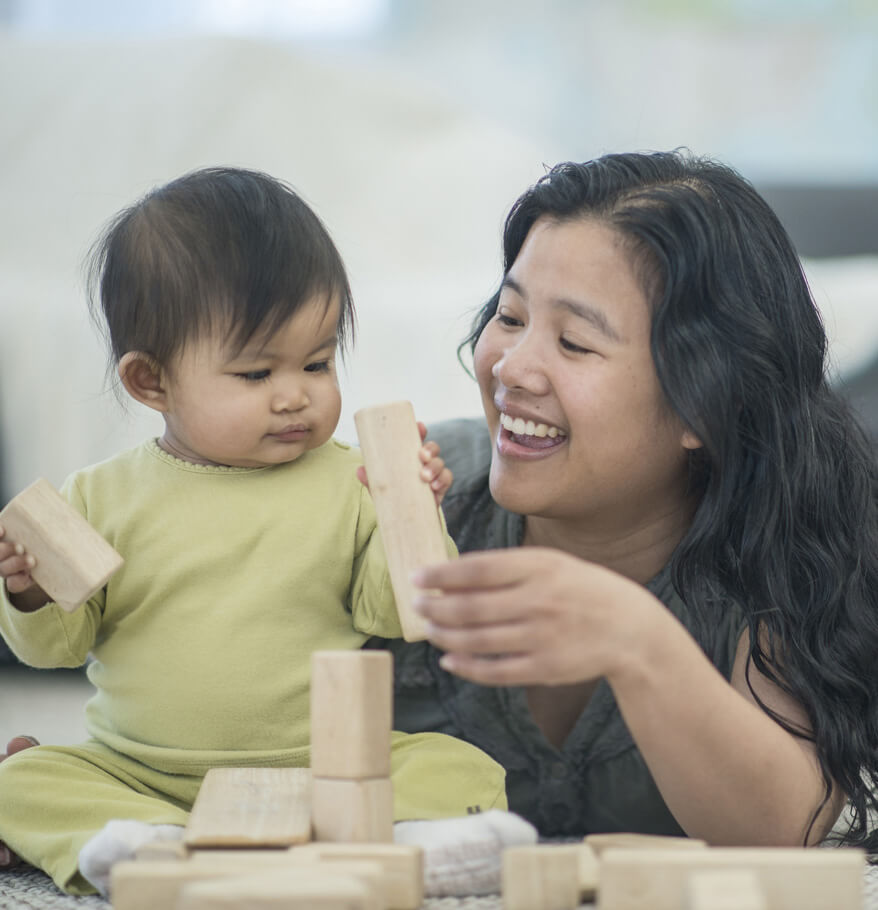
left=1, top=153, right=878, bottom=864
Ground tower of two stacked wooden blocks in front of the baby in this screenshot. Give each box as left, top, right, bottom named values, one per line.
left=311, top=651, right=393, bottom=843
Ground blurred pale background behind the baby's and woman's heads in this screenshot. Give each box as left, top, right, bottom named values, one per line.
left=0, top=0, right=878, bottom=502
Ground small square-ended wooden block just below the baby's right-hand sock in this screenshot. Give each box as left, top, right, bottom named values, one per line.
left=502, top=844, right=580, bottom=910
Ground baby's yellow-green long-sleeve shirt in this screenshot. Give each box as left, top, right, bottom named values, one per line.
left=0, top=441, right=412, bottom=772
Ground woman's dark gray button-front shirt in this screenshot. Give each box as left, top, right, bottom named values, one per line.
left=370, top=419, right=744, bottom=838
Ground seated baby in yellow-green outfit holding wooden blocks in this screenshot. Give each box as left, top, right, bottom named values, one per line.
left=0, top=168, right=533, bottom=895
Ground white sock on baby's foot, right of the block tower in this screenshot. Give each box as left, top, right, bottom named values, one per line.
left=393, top=809, right=537, bottom=897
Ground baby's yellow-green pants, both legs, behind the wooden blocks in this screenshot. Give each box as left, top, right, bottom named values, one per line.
left=0, top=733, right=506, bottom=894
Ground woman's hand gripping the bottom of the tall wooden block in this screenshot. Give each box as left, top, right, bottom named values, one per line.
left=414, top=547, right=669, bottom=685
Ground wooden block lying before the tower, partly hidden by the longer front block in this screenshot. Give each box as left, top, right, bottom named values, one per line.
left=289, top=841, right=424, bottom=910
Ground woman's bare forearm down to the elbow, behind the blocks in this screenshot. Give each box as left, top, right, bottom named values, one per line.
left=609, top=614, right=843, bottom=846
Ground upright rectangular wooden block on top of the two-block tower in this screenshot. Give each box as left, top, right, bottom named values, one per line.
left=311, top=651, right=393, bottom=780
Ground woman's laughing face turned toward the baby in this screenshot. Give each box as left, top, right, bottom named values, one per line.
left=474, top=218, right=698, bottom=535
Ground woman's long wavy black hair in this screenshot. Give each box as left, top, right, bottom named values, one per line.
left=462, top=151, right=878, bottom=852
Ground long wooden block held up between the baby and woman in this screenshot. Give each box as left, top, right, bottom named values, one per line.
left=354, top=401, right=448, bottom=641
